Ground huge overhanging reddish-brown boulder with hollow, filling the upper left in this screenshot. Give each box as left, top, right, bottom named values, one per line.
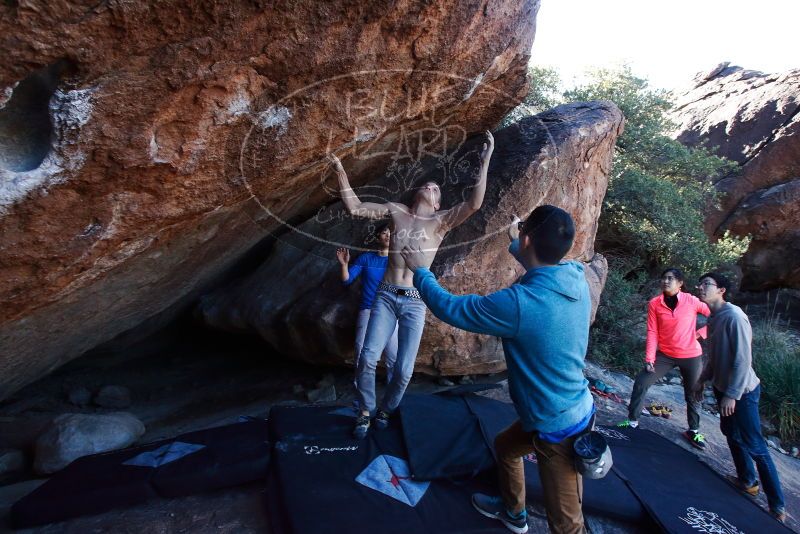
left=0, top=0, right=539, bottom=398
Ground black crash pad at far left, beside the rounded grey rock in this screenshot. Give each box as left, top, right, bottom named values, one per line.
left=11, top=419, right=270, bottom=528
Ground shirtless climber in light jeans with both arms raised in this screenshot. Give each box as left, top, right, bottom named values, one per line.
left=330, top=131, right=494, bottom=439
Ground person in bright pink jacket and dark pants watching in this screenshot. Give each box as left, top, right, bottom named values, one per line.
left=619, top=268, right=711, bottom=450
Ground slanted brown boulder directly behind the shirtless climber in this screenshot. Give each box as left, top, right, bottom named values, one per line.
left=198, top=102, right=623, bottom=375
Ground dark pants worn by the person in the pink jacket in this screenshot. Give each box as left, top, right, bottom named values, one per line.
left=628, top=351, right=703, bottom=430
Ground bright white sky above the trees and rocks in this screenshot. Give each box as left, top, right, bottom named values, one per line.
left=531, top=0, right=800, bottom=89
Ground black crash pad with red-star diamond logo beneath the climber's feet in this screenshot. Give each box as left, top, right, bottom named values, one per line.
left=267, top=407, right=507, bottom=534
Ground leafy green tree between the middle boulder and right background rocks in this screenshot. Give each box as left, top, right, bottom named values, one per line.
left=565, top=67, right=749, bottom=280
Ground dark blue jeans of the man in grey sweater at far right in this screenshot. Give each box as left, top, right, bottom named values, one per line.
left=714, top=385, right=784, bottom=510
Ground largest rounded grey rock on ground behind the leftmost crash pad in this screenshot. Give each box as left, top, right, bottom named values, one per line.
left=34, top=412, right=145, bottom=474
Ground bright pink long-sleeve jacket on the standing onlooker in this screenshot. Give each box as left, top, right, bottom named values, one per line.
left=644, top=291, right=711, bottom=363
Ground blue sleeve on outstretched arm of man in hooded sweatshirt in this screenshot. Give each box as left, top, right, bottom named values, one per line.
left=414, top=268, right=519, bottom=337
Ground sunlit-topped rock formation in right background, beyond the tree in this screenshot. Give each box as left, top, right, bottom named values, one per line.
left=674, top=63, right=800, bottom=290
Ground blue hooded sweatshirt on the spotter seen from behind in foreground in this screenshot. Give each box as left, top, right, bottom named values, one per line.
left=414, top=241, right=594, bottom=433
